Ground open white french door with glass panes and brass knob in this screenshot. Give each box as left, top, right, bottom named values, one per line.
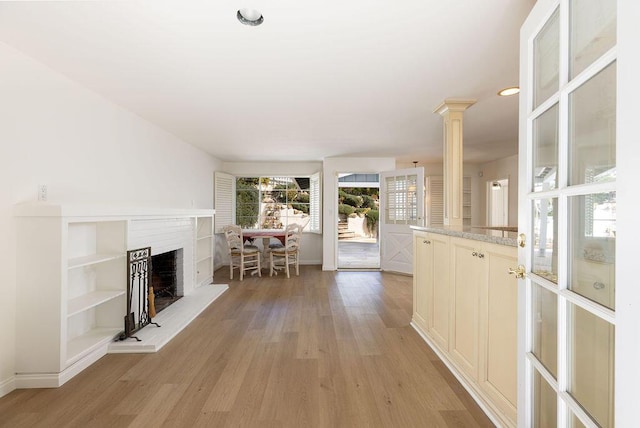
left=518, top=0, right=617, bottom=427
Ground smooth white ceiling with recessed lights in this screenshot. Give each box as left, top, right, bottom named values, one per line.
left=0, top=0, right=535, bottom=162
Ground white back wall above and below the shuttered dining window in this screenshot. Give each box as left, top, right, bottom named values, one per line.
left=221, top=162, right=326, bottom=268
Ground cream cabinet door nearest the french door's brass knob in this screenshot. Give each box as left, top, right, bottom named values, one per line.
left=478, top=244, right=518, bottom=423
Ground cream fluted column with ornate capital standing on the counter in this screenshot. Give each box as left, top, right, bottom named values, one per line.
left=433, top=99, right=476, bottom=226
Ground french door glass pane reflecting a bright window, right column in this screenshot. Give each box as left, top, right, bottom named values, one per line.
left=569, top=192, right=616, bottom=309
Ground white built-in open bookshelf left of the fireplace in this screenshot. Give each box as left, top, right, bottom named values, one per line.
left=17, top=212, right=127, bottom=386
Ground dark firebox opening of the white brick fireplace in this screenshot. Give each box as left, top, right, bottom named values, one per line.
left=150, top=248, right=183, bottom=313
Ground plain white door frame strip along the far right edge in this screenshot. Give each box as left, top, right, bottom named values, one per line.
left=615, top=1, right=640, bottom=427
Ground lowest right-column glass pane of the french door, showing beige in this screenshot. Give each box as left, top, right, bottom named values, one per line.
left=568, top=303, right=615, bottom=428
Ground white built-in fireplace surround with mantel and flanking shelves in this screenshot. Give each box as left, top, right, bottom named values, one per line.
left=14, top=203, right=214, bottom=388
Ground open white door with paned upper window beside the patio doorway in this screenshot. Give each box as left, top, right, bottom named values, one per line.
left=379, top=167, right=424, bottom=274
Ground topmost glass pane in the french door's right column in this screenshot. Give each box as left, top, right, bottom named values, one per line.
left=569, top=0, right=616, bottom=79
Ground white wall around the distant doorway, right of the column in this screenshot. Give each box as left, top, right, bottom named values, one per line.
left=473, top=155, right=518, bottom=226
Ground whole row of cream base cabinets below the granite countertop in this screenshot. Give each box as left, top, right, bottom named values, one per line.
left=413, top=231, right=518, bottom=426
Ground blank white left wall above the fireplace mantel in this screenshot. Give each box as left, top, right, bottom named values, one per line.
left=0, top=43, right=221, bottom=396
